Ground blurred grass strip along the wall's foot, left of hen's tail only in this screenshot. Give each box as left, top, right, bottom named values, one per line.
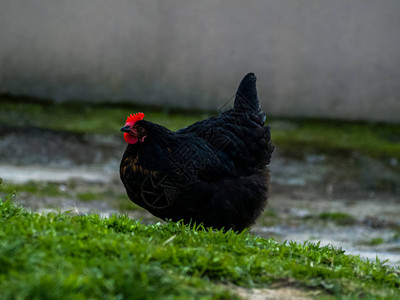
left=0, top=99, right=210, bottom=134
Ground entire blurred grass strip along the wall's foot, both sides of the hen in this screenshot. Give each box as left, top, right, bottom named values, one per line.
left=0, top=98, right=400, bottom=159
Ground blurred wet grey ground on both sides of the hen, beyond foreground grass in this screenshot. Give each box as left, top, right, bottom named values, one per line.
left=0, top=126, right=400, bottom=265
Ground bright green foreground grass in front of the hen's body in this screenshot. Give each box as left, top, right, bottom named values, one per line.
left=0, top=200, right=400, bottom=299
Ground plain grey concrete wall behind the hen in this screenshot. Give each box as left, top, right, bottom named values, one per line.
left=0, top=0, right=400, bottom=122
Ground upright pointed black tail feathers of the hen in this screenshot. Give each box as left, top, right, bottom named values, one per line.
left=234, top=73, right=260, bottom=113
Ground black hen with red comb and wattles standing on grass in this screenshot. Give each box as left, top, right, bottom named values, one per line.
left=120, top=73, right=274, bottom=231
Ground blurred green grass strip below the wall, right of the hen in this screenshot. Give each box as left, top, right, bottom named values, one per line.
left=272, top=119, right=400, bottom=159
